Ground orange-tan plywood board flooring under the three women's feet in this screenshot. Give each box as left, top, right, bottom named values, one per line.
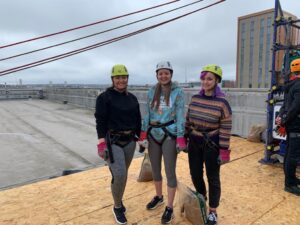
left=0, top=137, right=300, bottom=225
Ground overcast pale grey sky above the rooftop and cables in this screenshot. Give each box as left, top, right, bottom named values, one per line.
left=0, top=0, right=300, bottom=84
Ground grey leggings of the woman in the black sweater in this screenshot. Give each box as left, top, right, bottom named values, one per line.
left=107, top=141, right=136, bottom=208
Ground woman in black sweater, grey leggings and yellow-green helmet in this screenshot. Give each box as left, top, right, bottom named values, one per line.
left=95, top=64, right=141, bottom=224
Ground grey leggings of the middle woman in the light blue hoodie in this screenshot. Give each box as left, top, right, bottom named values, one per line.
left=148, top=137, right=177, bottom=188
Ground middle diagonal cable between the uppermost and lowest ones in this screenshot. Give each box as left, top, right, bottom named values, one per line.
left=0, top=0, right=204, bottom=61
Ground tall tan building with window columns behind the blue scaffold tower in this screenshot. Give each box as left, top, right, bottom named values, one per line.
left=236, top=9, right=299, bottom=88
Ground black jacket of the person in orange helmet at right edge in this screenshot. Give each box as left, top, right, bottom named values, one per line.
left=279, top=79, right=300, bottom=132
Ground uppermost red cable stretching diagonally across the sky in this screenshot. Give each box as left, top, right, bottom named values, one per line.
left=0, top=0, right=180, bottom=49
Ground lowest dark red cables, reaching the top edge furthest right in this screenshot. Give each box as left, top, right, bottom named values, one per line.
left=0, top=0, right=225, bottom=76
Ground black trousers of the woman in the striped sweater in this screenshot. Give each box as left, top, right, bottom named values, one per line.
left=188, top=135, right=221, bottom=208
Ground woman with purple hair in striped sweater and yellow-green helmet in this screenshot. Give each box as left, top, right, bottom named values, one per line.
left=186, top=64, right=232, bottom=225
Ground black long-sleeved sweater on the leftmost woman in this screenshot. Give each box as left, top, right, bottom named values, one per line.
left=95, top=88, right=141, bottom=138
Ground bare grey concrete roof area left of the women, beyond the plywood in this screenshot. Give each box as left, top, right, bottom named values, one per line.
left=0, top=100, right=108, bottom=189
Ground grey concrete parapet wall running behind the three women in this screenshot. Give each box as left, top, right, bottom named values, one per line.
left=45, top=88, right=267, bottom=137
